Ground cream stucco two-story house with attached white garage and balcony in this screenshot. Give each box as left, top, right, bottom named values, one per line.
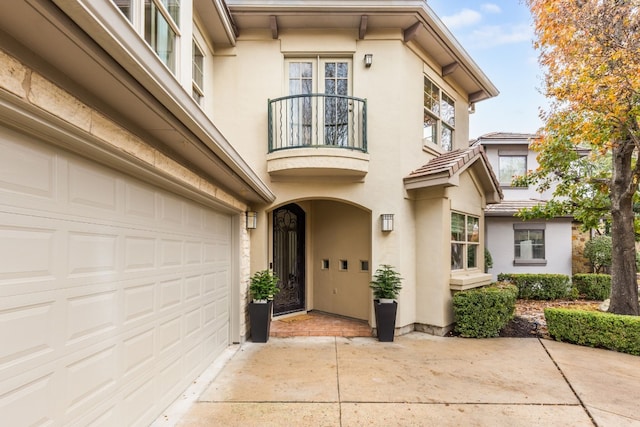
left=0, top=0, right=501, bottom=425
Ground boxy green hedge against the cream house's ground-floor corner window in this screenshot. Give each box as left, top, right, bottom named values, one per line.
left=453, top=284, right=518, bottom=338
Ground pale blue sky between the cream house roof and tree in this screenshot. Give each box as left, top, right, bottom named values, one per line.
left=427, top=0, right=546, bottom=139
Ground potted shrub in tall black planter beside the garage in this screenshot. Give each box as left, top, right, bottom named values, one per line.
left=249, top=270, right=280, bottom=342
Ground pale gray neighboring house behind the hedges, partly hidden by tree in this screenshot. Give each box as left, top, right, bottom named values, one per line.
left=471, top=132, right=579, bottom=279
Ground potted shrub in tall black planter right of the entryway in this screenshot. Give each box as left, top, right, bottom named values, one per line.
left=369, top=264, right=402, bottom=342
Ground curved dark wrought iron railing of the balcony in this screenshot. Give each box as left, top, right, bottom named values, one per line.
left=269, top=93, right=367, bottom=153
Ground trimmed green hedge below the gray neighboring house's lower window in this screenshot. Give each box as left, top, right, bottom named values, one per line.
left=498, top=273, right=574, bottom=300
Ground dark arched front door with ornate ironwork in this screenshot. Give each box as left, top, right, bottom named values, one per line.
left=273, top=203, right=305, bottom=314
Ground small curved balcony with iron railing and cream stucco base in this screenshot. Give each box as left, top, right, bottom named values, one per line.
left=267, top=94, right=369, bottom=181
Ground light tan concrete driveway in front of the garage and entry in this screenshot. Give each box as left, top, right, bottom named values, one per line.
left=153, top=333, right=640, bottom=427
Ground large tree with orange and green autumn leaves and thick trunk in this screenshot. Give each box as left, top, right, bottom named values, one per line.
left=520, top=0, right=640, bottom=315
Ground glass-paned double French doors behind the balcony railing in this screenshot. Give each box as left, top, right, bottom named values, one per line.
left=287, top=58, right=353, bottom=147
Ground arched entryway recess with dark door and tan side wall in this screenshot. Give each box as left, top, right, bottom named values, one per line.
left=272, top=199, right=372, bottom=320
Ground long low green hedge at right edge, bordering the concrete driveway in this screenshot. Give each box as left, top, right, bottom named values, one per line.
left=544, top=308, right=640, bottom=355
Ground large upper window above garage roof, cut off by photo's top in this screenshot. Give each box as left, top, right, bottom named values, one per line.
left=113, top=0, right=180, bottom=73
